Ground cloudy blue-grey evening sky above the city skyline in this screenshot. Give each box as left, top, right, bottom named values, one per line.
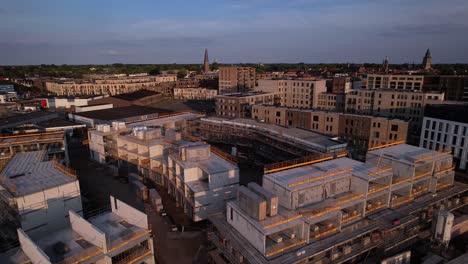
left=0, top=0, right=468, bottom=65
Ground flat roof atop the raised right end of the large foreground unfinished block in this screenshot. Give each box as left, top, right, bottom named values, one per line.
left=368, top=144, right=452, bottom=165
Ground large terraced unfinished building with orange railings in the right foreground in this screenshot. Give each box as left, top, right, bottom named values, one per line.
left=208, top=144, right=468, bottom=263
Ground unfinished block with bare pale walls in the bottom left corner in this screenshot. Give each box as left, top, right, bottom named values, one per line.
left=0, top=197, right=155, bottom=264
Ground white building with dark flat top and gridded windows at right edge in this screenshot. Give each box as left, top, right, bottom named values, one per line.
left=419, top=105, right=468, bottom=170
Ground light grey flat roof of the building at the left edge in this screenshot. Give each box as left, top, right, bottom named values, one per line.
left=0, top=151, right=77, bottom=196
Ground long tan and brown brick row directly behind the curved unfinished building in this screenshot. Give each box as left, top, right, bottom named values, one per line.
left=252, top=105, right=408, bottom=153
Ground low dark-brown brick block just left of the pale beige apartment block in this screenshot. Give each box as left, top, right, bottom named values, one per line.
left=216, top=91, right=279, bottom=118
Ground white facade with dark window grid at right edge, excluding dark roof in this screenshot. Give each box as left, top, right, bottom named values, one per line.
left=419, top=117, right=468, bottom=170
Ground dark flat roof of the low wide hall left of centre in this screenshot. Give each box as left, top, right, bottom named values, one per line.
left=75, top=105, right=172, bottom=121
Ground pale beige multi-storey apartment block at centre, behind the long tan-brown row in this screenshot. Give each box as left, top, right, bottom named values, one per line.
left=255, top=79, right=327, bottom=108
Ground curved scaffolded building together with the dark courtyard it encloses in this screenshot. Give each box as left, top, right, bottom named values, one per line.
left=188, top=117, right=347, bottom=184
